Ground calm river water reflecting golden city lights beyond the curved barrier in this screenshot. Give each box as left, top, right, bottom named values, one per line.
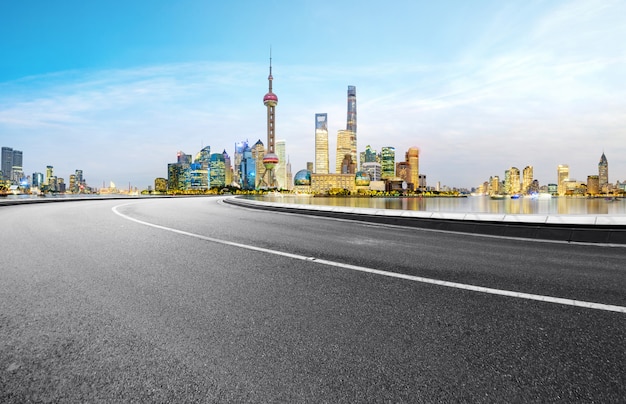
left=255, top=195, right=626, bottom=215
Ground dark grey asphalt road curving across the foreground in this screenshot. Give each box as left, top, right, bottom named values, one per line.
left=0, top=198, right=626, bottom=403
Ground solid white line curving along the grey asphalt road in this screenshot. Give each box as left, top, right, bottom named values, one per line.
left=111, top=204, right=626, bottom=313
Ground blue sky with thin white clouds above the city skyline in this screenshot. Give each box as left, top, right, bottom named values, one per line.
left=0, top=0, right=626, bottom=189
